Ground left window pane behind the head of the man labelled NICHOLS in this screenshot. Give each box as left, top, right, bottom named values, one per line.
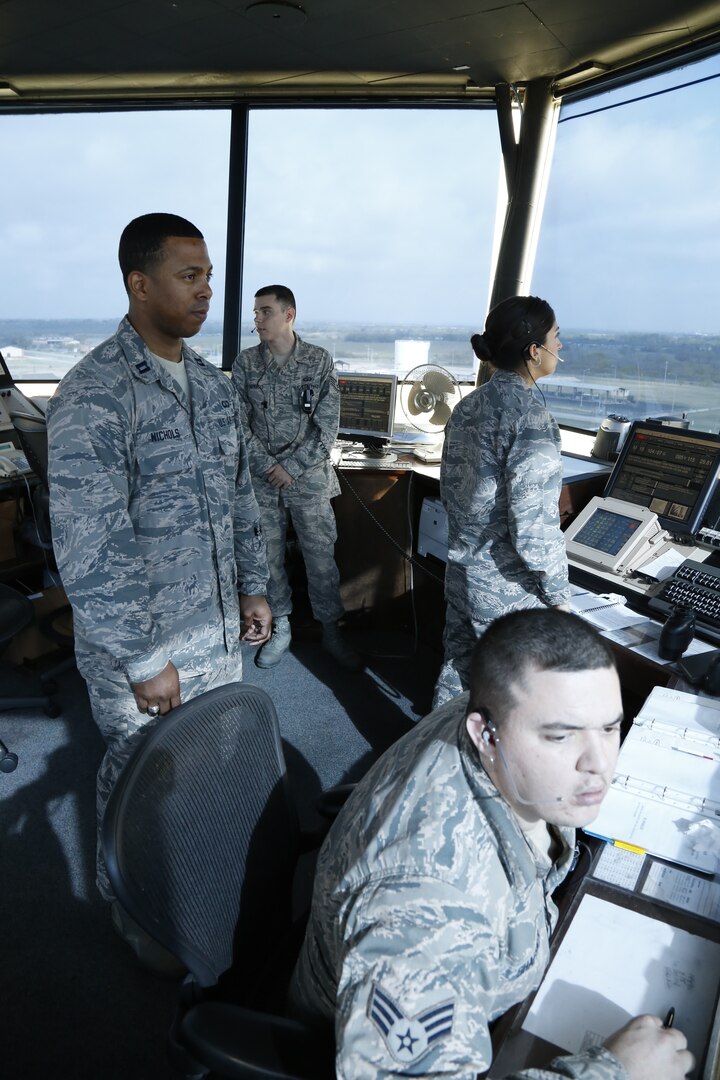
left=0, top=110, right=230, bottom=381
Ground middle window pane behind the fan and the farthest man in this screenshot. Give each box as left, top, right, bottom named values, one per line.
left=242, top=108, right=500, bottom=379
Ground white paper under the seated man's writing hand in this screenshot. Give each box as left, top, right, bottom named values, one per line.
left=522, top=896, right=720, bottom=1061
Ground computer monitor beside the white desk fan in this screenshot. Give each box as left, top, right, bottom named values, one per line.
left=338, top=372, right=397, bottom=450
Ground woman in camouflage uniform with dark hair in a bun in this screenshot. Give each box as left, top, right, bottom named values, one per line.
left=433, top=296, right=570, bottom=706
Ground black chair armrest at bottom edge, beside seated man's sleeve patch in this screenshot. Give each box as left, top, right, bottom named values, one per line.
left=180, top=1001, right=335, bottom=1080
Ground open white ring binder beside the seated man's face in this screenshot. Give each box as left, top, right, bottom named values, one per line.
left=585, top=687, right=720, bottom=874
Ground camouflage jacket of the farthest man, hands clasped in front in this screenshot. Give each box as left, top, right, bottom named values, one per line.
left=232, top=334, right=340, bottom=502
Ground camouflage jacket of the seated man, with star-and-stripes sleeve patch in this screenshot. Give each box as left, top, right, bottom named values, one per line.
left=290, top=694, right=627, bottom=1080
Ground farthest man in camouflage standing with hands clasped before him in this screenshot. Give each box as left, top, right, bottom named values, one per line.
left=232, top=285, right=362, bottom=670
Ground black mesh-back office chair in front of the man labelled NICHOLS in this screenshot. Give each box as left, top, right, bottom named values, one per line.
left=103, top=683, right=335, bottom=1080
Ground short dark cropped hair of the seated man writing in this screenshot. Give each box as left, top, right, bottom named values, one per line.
left=467, top=608, right=616, bottom=723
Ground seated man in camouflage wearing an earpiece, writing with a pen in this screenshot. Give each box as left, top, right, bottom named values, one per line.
left=290, top=609, right=693, bottom=1080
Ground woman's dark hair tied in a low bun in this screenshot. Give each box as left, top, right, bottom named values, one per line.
left=470, top=296, right=555, bottom=372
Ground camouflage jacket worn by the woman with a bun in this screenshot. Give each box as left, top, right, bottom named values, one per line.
left=440, top=372, right=569, bottom=623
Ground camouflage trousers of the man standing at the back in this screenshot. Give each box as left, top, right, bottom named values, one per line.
left=258, top=488, right=344, bottom=623
